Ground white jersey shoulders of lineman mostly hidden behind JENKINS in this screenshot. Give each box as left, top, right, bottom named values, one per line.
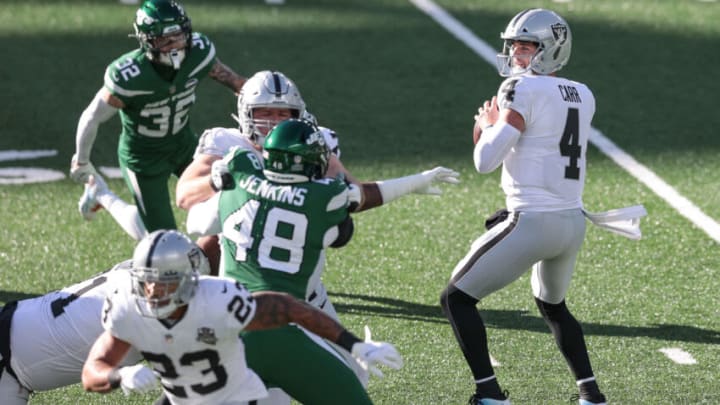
left=193, top=127, right=340, bottom=162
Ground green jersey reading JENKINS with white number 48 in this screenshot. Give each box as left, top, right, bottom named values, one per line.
left=219, top=149, right=348, bottom=300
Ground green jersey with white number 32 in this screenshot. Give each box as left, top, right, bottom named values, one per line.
left=105, top=32, right=215, bottom=174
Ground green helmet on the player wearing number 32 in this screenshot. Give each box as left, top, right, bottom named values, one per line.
left=133, top=0, right=192, bottom=69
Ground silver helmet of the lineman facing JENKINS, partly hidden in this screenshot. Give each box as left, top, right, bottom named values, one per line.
left=234, top=70, right=306, bottom=146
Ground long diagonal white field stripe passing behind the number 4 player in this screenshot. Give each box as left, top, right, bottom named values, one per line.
left=409, top=0, right=720, bottom=243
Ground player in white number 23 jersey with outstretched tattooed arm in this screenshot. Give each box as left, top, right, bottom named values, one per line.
left=82, top=230, right=402, bottom=405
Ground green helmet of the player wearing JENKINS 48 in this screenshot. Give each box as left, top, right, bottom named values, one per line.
left=263, top=118, right=330, bottom=183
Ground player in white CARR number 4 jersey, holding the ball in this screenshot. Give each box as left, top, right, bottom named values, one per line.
left=441, top=9, right=605, bottom=405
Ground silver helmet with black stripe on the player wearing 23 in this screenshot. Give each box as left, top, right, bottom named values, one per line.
left=131, top=230, right=209, bottom=319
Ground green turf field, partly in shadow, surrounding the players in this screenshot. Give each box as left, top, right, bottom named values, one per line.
left=0, top=0, right=720, bottom=405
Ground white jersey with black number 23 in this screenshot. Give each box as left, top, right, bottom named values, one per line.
left=103, top=276, right=267, bottom=405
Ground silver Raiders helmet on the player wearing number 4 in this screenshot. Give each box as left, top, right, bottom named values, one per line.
left=497, top=8, right=572, bottom=77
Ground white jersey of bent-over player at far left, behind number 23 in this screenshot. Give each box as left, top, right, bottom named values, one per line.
left=10, top=261, right=141, bottom=391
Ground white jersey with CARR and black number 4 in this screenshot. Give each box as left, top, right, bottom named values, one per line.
left=497, top=75, right=595, bottom=211
